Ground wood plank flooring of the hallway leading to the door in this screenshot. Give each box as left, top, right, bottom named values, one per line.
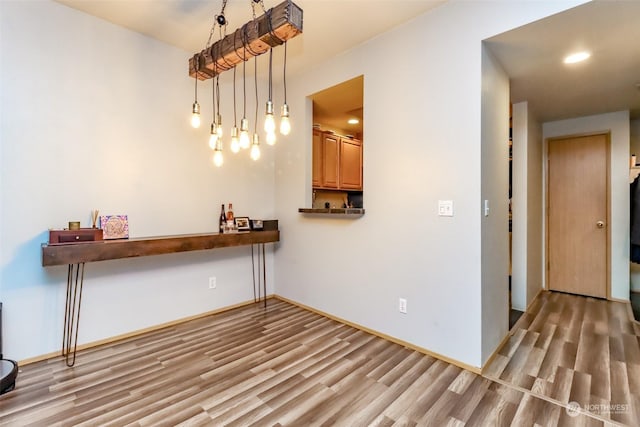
left=484, top=292, right=640, bottom=426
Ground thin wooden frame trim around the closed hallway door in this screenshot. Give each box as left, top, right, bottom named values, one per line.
left=543, top=130, right=611, bottom=300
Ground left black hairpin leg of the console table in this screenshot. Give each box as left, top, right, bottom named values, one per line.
left=62, top=262, right=84, bottom=367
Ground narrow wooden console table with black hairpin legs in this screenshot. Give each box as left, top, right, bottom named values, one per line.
left=42, top=230, right=280, bottom=366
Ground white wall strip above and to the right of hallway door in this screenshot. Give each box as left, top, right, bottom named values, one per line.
left=542, top=111, right=629, bottom=300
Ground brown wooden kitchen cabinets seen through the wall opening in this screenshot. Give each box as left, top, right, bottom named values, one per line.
left=313, top=129, right=362, bottom=191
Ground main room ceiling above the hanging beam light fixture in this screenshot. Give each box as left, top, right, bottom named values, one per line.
left=56, top=0, right=445, bottom=78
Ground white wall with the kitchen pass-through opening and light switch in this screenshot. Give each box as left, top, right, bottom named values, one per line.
left=276, top=1, right=579, bottom=367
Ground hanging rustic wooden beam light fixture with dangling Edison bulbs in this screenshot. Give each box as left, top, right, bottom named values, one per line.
left=189, top=0, right=302, bottom=166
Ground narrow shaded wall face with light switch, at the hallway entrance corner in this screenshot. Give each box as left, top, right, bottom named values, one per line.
left=481, top=44, right=509, bottom=364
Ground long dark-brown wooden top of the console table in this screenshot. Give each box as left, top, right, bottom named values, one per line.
left=42, top=230, right=280, bottom=267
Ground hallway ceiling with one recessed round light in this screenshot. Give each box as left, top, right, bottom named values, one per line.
left=487, top=0, right=640, bottom=122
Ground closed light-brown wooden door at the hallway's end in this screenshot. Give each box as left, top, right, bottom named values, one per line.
left=547, top=134, right=609, bottom=298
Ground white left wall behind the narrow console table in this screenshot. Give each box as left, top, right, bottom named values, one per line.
left=0, top=1, right=275, bottom=359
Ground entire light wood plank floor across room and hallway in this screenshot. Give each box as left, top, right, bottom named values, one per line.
left=0, top=296, right=640, bottom=427
